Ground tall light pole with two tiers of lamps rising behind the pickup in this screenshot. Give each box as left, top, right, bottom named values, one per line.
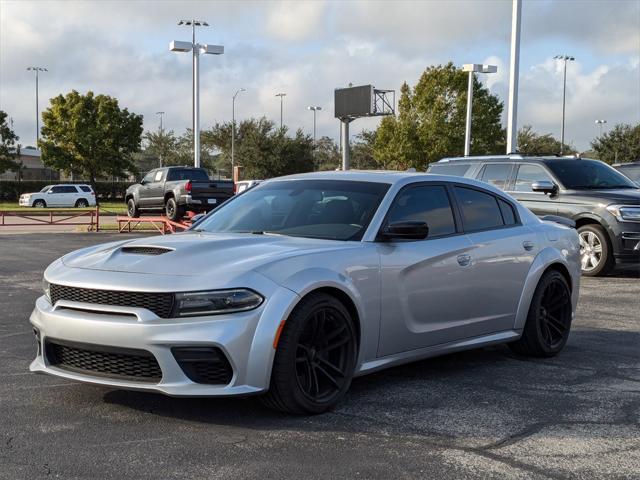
left=169, top=20, right=224, bottom=167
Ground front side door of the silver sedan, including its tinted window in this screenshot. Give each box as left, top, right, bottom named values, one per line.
left=378, top=182, right=473, bottom=356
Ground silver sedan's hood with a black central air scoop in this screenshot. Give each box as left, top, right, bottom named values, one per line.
left=62, top=232, right=359, bottom=279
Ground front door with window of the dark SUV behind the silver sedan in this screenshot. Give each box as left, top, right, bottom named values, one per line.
left=509, top=163, right=558, bottom=217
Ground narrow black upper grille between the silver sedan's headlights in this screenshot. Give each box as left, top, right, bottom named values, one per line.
left=50, top=283, right=173, bottom=318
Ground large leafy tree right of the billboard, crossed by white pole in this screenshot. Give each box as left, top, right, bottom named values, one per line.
left=373, top=63, right=504, bottom=170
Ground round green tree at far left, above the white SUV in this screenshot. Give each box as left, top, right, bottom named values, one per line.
left=38, top=90, right=142, bottom=202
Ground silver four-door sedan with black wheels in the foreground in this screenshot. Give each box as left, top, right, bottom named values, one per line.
left=31, top=172, right=580, bottom=413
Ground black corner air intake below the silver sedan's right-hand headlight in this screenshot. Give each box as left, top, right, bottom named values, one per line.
left=171, top=347, right=233, bottom=385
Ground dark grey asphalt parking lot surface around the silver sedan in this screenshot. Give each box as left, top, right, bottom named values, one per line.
left=0, top=233, right=640, bottom=479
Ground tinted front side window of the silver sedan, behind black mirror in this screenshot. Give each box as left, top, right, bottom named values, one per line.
left=387, top=185, right=456, bottom=237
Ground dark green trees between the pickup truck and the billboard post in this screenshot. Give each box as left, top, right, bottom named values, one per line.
left=201, top=117, right=314, bottom=179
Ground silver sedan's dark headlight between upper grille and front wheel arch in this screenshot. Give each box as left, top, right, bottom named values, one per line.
left=176, top=288, right=264, bottom=317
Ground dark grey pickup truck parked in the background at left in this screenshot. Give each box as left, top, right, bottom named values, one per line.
left=125, top=167, right=234, bottom=221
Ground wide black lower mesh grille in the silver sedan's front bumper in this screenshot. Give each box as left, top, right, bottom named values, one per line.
left=45, top=339, right=162, bottom=383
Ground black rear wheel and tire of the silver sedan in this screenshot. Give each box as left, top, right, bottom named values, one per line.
left=509, top=270, right=572, bottom=357
